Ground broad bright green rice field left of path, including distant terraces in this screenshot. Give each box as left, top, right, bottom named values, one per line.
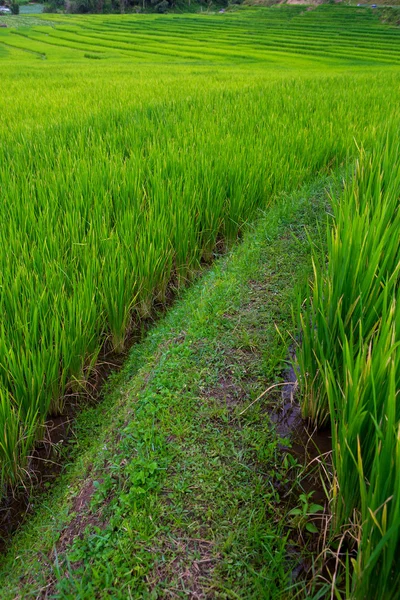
left=0, top=6, right=400, bottom=598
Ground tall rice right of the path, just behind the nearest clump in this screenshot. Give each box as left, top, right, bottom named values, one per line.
left=298, top=136, right=400, bottom=426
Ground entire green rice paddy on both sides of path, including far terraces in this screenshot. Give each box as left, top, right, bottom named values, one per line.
left=0, top=5, right=400, bottom=600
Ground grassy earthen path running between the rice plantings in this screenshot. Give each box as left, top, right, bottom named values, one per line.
left=0, top=180, right=328, bottom=600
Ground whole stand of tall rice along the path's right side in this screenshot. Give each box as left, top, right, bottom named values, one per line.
left=299, top=135, right=400, bottom=600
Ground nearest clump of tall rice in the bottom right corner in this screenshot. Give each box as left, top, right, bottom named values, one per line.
left=325, top=301, right=400, bottom=600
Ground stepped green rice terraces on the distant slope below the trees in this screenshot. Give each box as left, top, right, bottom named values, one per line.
left=1, top=7, right=399, bottom=64
